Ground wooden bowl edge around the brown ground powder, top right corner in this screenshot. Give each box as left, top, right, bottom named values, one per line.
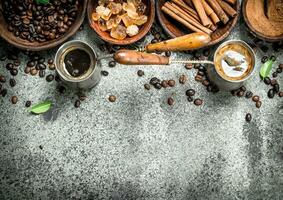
left=242, top=0, right=283, bottom=42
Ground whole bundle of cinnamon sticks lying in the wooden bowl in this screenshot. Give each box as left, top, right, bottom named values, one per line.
left=162, top=0, right=237, bottom=35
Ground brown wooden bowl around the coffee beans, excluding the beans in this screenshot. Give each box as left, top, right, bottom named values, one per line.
left=0, top=0, right=88, bottom=51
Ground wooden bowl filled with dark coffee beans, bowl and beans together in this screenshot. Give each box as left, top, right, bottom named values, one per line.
left=0, top=0, right=87, bottom=51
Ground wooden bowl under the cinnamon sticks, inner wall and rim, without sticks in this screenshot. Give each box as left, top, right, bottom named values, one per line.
left=156, top=0, right=240, bottom=47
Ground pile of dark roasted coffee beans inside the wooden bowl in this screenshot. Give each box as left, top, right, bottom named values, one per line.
left=2, top=0, right=79, bottom=42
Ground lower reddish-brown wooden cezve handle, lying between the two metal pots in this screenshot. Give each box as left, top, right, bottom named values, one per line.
left=114, top=50, right=169, bottom=65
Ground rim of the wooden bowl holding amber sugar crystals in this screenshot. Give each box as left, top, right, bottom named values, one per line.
left=87, top=0, right=155, bottom=45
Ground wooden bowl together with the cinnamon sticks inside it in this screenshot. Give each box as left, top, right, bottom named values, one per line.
left=156, top=0, right=240, bottom=49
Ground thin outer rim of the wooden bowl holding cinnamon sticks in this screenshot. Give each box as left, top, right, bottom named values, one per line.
left=156, top=0, right=241, bottom=49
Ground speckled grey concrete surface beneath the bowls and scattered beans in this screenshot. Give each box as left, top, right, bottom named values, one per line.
left=0, top=4, right=283, bottom=200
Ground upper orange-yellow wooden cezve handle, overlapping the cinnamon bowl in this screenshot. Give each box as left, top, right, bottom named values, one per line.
left=145, top=33, right=211, bottom=52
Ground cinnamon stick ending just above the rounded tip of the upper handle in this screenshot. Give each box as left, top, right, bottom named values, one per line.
left=169, top=2, right=212, bottom=35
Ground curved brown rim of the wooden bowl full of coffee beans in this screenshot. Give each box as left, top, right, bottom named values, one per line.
left=0, top=0, right=88, bottom=51
